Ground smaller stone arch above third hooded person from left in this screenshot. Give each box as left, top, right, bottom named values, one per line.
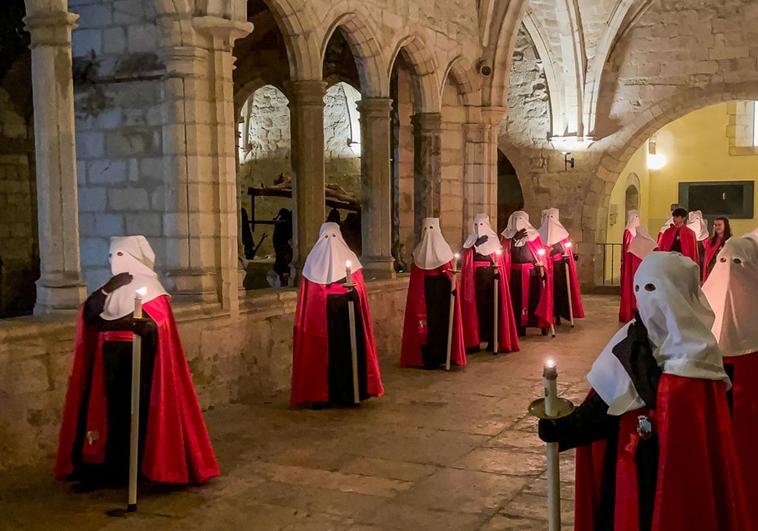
left=387, top=35, right=441, bottom=112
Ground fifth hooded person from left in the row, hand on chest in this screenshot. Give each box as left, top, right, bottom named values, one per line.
left=500, top=210, right=556, bottom=336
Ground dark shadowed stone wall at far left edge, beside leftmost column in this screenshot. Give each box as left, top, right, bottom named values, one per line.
left=0, top=89, right=39, bottom=317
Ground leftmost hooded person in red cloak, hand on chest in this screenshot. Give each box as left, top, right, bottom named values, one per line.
left=55, top=236, right=219, bottom=491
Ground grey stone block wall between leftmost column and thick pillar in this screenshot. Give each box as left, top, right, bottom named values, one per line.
left=69, top=0, right=167, bottom=289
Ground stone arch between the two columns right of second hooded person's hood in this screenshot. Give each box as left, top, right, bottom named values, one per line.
left=320, top=11, right=389, bottom=98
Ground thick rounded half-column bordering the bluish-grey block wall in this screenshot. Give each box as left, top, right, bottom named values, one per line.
left=161, top=44, right=221, bottom=302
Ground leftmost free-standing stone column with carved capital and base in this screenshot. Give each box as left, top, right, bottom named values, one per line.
left=24, top=0, right=86, bottom=315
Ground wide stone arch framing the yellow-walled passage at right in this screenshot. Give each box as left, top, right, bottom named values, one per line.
left=588, top=82, right=758, bottom=282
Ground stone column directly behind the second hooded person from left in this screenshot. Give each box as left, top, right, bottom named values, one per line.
left=287, top=80, right=326, bottom=273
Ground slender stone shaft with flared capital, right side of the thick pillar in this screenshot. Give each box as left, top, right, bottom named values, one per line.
left=193, top=16, right=253, bottom=313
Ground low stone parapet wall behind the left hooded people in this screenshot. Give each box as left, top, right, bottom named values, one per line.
left=0, top=278, right=408, bottom=470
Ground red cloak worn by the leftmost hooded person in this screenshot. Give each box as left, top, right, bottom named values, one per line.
left=55, top=295, right=220, bottom=484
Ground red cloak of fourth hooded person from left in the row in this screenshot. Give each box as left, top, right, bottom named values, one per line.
left=458, top=247, right=519, bottom=352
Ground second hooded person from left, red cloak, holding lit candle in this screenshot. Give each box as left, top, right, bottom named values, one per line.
left=290, top=223, right=384, bottom=407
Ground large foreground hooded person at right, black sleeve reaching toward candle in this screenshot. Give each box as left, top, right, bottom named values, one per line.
left=539, top=252, right=751, bottom=531
